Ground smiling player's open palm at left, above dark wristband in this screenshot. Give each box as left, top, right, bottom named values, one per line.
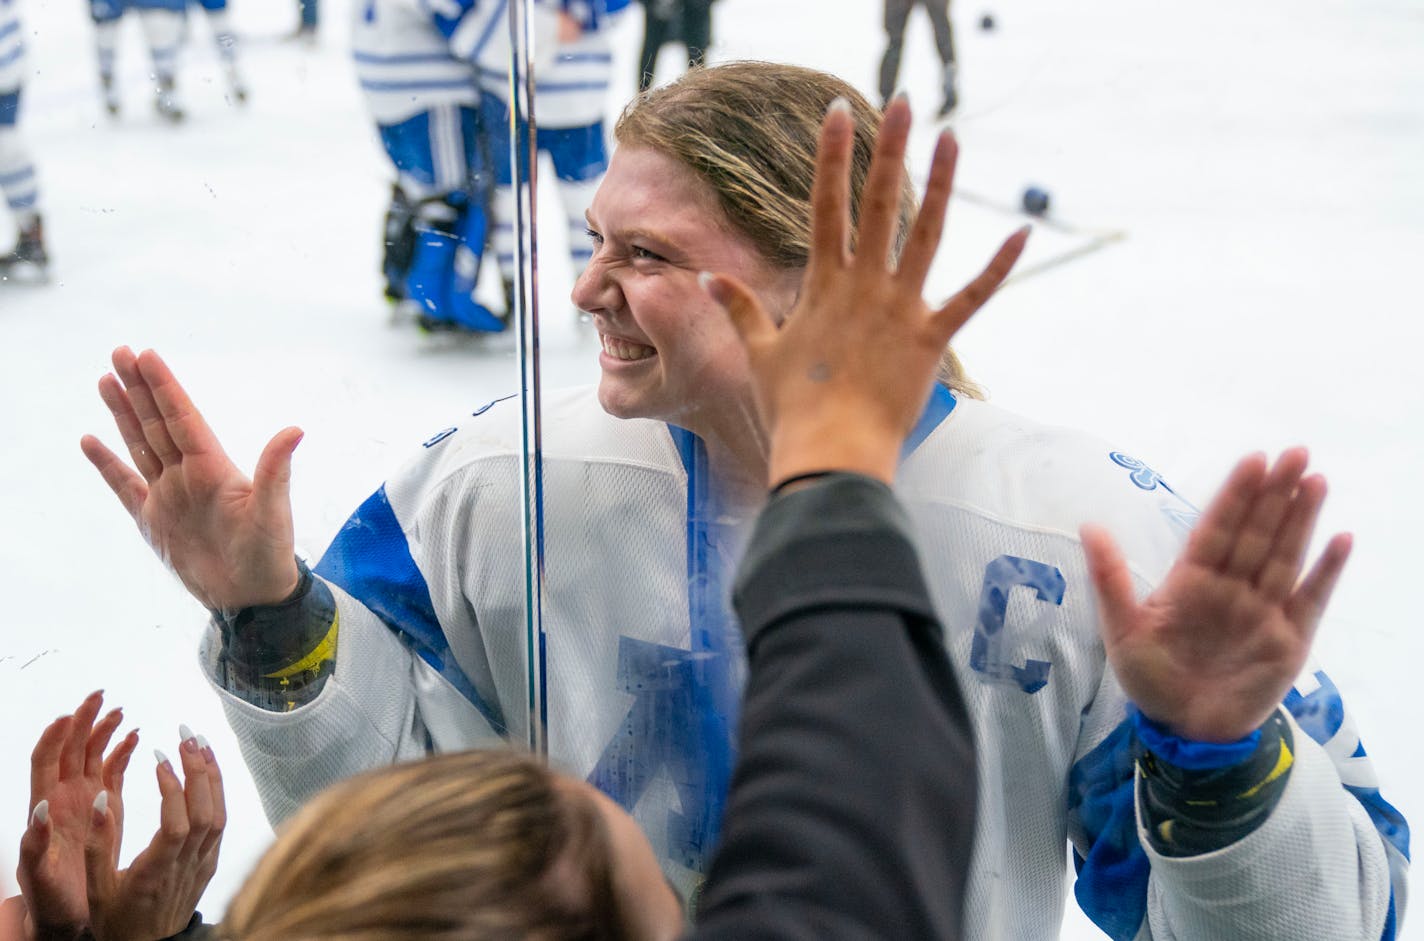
left=80, top=346, right=302, bottom=611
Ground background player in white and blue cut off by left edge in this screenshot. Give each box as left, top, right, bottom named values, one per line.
left=0, top=0, right=50, bottom=280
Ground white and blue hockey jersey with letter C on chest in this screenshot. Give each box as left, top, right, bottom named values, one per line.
left=202, top=390, right=1408, bottom=941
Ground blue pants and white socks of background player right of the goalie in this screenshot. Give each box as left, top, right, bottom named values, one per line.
left=480, top=94, right=608, bottom=283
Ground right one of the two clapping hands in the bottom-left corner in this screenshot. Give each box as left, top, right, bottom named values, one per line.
left=85, top=727, right=228, bottom=941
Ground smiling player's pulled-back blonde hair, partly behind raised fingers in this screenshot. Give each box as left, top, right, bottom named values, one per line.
left=614, top=61, right=981, bottom=399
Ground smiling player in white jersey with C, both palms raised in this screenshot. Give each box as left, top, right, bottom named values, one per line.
left=84, top=63, right=1408, bottom=941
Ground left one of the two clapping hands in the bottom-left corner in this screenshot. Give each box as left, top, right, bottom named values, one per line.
left=16, top=692, right=138, bottom=937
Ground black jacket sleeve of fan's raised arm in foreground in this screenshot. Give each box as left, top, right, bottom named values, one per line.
left=692, top=474, right=977, bottom=941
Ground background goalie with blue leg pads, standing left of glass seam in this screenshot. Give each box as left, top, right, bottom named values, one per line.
left=353, top=0, right=506, bottom=332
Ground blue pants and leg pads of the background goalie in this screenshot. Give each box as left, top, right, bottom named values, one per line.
left=380, top=105, right=504, bottom=332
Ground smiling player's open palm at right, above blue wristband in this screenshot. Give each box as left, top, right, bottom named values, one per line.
left=1082, top=448, right=1350, bottom=742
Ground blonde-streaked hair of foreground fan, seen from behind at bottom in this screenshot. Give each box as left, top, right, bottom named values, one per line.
left=219, top=750, right=624, bottom=941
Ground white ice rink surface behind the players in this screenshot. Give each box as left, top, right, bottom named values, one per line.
left=0, top=0, right=1424, bottom=938
